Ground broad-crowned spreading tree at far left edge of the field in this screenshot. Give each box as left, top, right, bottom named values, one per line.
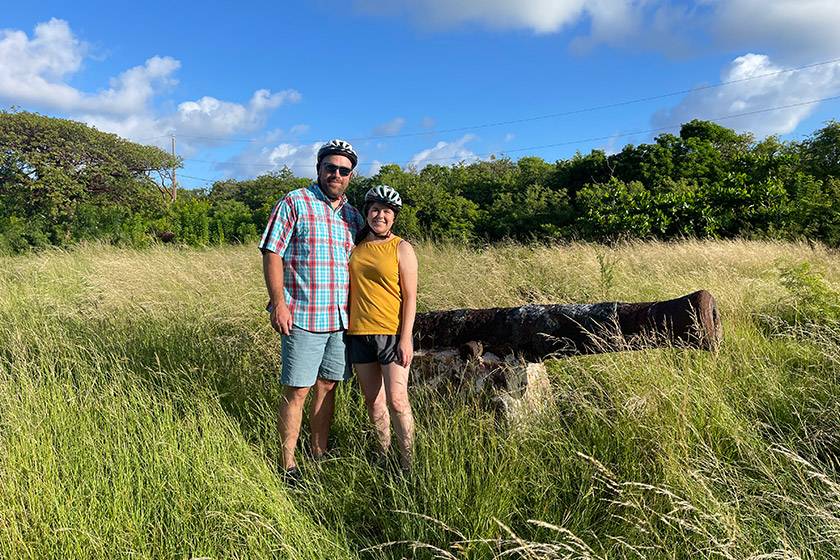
left=0, top=111, right=181, bottom=244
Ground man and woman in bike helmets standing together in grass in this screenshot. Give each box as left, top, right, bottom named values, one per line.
left=259, top=140, right=417, bottom=483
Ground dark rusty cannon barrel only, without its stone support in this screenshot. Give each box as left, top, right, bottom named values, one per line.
left=414, top=290, right=722, bottom=362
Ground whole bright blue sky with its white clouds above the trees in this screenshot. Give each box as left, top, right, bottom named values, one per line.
left=0, top=0, right=840, bottom=187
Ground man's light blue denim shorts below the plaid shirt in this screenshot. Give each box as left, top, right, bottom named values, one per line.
left=280, top=326, right=350, bottom=387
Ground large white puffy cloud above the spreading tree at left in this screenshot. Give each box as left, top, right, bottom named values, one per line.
left=0, top=19, right=301, bottom=153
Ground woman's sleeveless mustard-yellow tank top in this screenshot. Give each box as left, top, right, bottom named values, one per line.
left=347, top=236, right=402, bottom=334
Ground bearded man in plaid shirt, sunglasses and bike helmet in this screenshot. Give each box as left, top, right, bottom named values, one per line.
left=260, top=140, right=363, bottom=484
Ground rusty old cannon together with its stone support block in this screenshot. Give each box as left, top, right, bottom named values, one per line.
left=411, top=290, right=722, bottom=421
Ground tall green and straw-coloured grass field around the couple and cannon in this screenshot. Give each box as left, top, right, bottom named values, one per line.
left=0, top=241, right=840, bottom=560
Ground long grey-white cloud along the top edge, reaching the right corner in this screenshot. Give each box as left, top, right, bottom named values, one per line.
left=355, top=0, right=840, bottom=61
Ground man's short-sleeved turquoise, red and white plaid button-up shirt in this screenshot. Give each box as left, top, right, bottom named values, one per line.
left=260, top=185, right=364, bottom=332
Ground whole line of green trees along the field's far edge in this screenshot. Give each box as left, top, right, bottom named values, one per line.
left=0, top=112, right=840, bottom=253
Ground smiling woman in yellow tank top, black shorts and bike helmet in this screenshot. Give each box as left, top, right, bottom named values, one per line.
left=347, top=185, right=417, bottom=470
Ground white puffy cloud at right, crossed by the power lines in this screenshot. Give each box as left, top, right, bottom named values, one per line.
left=653, top=54, right=840, bottom=137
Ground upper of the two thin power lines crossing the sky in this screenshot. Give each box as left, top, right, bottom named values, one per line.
left=161, top=54, right=840, bottom=144
